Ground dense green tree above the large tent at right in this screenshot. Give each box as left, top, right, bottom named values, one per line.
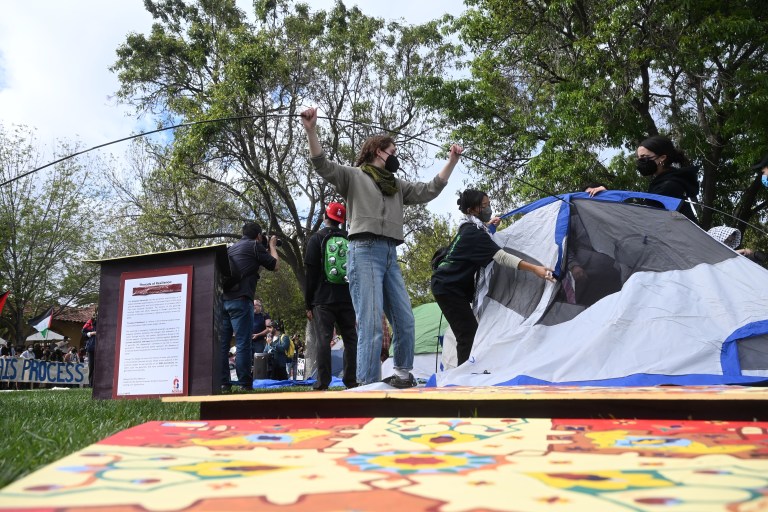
left=420, top=0, right=768, bottom=238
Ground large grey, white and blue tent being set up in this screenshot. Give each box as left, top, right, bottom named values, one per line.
left=429, top=191, right=768, bottom=386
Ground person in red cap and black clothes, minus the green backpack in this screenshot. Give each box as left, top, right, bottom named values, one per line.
left=304, top=203, right=357, bottom=390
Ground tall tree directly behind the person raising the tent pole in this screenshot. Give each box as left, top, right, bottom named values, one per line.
left=113, top=0, right=452, bottom=287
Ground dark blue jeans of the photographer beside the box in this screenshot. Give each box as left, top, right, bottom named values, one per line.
left=219, top=297, right=253, bottom=388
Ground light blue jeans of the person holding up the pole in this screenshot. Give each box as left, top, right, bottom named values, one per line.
left=347, top=238, right=416, bottom=384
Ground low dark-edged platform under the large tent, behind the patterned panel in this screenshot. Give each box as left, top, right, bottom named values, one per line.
left=163, top=386, right=768, bottom=421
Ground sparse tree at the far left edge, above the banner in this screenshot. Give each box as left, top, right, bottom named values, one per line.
left=0, top=125, right=102, bottom=344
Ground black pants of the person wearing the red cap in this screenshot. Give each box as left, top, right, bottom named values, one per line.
left=312, top=302, right=357, bottom=389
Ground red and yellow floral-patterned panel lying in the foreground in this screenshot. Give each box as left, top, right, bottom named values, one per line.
left=0, top=418, right=768, bottom=512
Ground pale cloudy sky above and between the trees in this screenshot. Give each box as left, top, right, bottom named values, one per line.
left=0, top=0, right=466, bottom=222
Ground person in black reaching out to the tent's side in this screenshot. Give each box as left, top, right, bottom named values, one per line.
left=431, top=189, right=555, bottom=364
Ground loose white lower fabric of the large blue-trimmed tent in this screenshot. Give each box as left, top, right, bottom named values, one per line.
left=437, top=258, right=768, bottom=386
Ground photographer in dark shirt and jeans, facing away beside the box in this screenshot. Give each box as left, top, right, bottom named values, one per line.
left=220, top=222, right=279, bottom=389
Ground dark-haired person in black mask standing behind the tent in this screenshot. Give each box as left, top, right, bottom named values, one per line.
left=586, top=135, right=699, bottom=223
